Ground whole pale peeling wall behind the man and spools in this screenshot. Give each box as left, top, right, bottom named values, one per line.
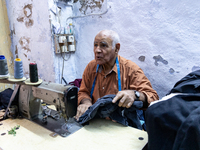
left=7, top=0, right=200, bottom=97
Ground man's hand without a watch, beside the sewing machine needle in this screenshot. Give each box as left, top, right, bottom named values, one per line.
left=75, top=99, right=92, bottom=120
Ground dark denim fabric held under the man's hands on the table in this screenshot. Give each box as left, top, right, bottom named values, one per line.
left=79, top=94, right=143, bottom=129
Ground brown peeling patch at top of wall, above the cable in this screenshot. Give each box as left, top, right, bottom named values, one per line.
left=77, top=0, right=104, bottom=15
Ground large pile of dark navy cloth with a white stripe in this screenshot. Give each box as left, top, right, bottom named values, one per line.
left=145, top=70, right=200, bottom=150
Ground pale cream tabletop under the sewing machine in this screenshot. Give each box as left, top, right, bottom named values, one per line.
left=0, top=119, right=148, bottom=150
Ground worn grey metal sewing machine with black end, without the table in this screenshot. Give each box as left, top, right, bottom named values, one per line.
left=0, top=80, right=82, bottom=137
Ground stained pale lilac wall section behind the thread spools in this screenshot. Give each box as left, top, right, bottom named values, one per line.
left=6, top=0, right=55, bottom=81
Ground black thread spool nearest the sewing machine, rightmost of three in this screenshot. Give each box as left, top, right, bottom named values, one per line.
left=29, top=63, right=38, bottom=82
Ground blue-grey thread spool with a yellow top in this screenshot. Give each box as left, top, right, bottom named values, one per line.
left=14, top=58, right=24, bottom=79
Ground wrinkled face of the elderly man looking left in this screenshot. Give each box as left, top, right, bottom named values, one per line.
left=94, top=32, right=116, bottom=65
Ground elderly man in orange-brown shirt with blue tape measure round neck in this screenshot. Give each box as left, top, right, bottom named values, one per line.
left=76, top=30, right=159, bottom=120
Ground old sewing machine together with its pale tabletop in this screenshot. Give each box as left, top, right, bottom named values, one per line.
left=0, top=79, right=148, bottom=150
